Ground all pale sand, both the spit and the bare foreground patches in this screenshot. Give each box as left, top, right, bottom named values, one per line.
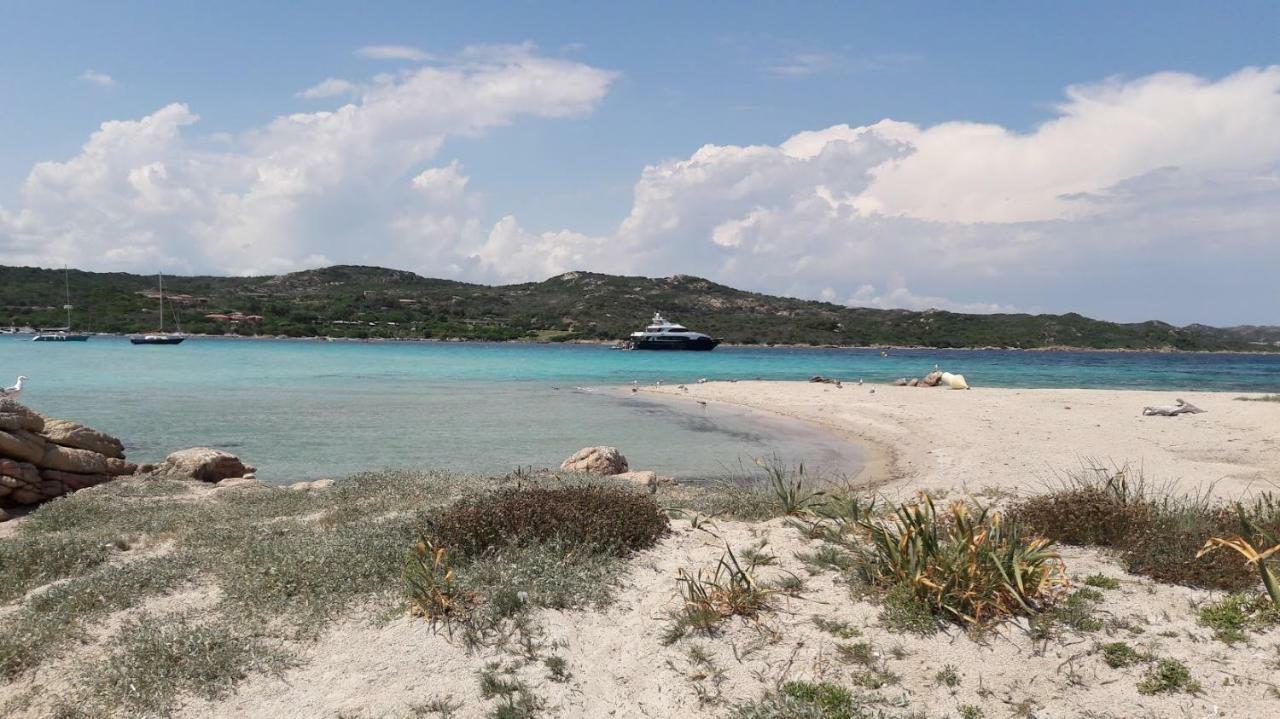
left=5, top=383, right=1280, bottom=719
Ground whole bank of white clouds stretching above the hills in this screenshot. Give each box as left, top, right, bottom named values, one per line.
left=0, top=55, right=1280, bottom=317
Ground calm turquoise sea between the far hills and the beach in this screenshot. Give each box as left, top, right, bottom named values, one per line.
left=0, top=336, right=1280, bottom=482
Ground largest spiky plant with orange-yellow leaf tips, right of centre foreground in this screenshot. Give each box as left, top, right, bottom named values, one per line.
left=859, top=494, right=1066, bottom=624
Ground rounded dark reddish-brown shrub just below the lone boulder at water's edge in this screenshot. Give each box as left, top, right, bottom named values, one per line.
left=430, top=486, right=669, bottom=557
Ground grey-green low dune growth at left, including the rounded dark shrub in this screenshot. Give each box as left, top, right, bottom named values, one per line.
left=0, top=472, right=667, bottom=715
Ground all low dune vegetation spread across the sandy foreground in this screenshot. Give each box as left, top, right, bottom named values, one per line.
left=0, top=455, right=1280, bottom=719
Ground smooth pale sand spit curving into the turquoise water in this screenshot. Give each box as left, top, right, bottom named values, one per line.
left=645, top=381, right=1280, bottom=499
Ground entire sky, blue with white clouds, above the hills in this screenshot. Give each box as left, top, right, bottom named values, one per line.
left=0, top=0, right=1280, bottom=325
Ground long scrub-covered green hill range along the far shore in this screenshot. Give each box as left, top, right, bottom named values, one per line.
left=0, top=265, right=1280, bottom=352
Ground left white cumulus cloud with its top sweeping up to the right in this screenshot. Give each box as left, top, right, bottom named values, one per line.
left=0, top=47, right=614, bottom=274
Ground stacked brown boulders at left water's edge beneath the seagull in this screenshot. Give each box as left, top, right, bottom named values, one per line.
left=0, top=399, right=129, bottom=509
